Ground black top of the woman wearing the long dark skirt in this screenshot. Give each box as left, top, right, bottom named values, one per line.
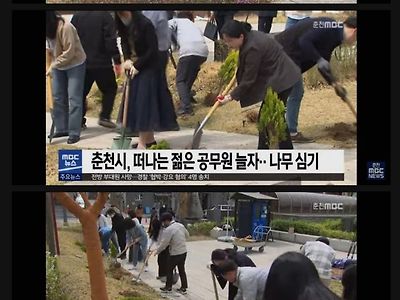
left=118, top=12, right=159, bottom=71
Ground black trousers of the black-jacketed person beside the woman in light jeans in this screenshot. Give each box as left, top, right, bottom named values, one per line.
left=82, top=67, right=117, bottom=124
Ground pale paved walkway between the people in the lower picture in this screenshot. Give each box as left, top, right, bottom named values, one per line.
left=117, top=240, right=347, bottom=300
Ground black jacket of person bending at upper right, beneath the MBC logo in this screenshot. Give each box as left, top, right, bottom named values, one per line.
left=274, top=17, right=343, bottom=73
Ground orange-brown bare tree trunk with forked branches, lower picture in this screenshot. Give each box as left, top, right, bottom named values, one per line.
left=55, top=193, right=108, bottom=300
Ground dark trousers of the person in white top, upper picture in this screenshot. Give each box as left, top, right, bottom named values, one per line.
left=176, top=55, right=207, bottom=113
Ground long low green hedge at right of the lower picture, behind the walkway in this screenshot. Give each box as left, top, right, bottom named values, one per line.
left=271, top=219, right=355, bottom=240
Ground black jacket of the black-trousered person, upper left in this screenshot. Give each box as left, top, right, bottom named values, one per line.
left=71, top=11, right=121, bottom=69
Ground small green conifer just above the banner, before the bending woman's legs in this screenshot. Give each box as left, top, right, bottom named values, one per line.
left=257, top=87, right=286, bottom=149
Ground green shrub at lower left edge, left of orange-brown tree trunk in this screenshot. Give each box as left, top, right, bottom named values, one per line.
left=46, top=252, right=67, bottom=300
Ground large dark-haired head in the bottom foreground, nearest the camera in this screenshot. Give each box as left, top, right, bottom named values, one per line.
left=264, top=252, right=340, bottom=300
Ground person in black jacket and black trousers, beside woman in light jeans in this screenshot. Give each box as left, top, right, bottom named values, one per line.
left=71, top=11, right=121, bottom=128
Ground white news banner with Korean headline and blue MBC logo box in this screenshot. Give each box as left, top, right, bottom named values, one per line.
left=58, top=150, right=344, bottom=181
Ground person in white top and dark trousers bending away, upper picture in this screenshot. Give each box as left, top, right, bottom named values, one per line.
left=168, top=12, right=208, bottom=117
